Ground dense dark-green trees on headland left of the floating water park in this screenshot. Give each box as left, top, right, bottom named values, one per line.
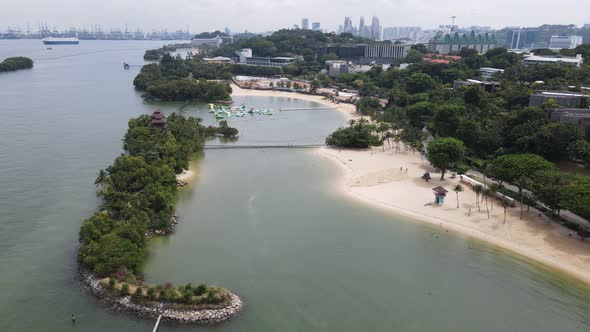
left=133, top=53, right=231, bottom=101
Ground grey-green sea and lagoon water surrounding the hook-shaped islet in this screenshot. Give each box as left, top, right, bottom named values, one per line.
left=0, top=41, right=590, bottom=332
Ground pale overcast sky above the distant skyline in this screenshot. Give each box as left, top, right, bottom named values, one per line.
left=0, top=0, right=590, bottom=32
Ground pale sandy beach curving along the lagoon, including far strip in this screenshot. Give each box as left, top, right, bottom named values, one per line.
left=232, top=85, right=590, bottom=283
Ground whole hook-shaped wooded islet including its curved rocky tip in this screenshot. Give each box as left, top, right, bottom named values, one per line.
left=78, top=111, right=243, bottom=323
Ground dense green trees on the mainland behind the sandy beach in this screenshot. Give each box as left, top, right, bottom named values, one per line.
left=322, top=45, right=590, bottom=232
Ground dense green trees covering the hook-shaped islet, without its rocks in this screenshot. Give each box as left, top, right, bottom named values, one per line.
left=78, top=114, right=236, bottom=303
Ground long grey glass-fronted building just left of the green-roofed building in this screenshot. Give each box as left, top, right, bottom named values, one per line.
left=318, top=43, right=411, bottom=64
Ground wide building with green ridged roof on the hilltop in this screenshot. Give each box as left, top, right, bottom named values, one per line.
left=428, top=31, right=497, bottom=54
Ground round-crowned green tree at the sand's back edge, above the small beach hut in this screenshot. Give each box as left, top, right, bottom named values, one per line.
left=427, top=137, right=465, bottom=180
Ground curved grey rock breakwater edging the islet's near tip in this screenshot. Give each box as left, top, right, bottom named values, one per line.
left=80, top=270, right=244, bottom=324
